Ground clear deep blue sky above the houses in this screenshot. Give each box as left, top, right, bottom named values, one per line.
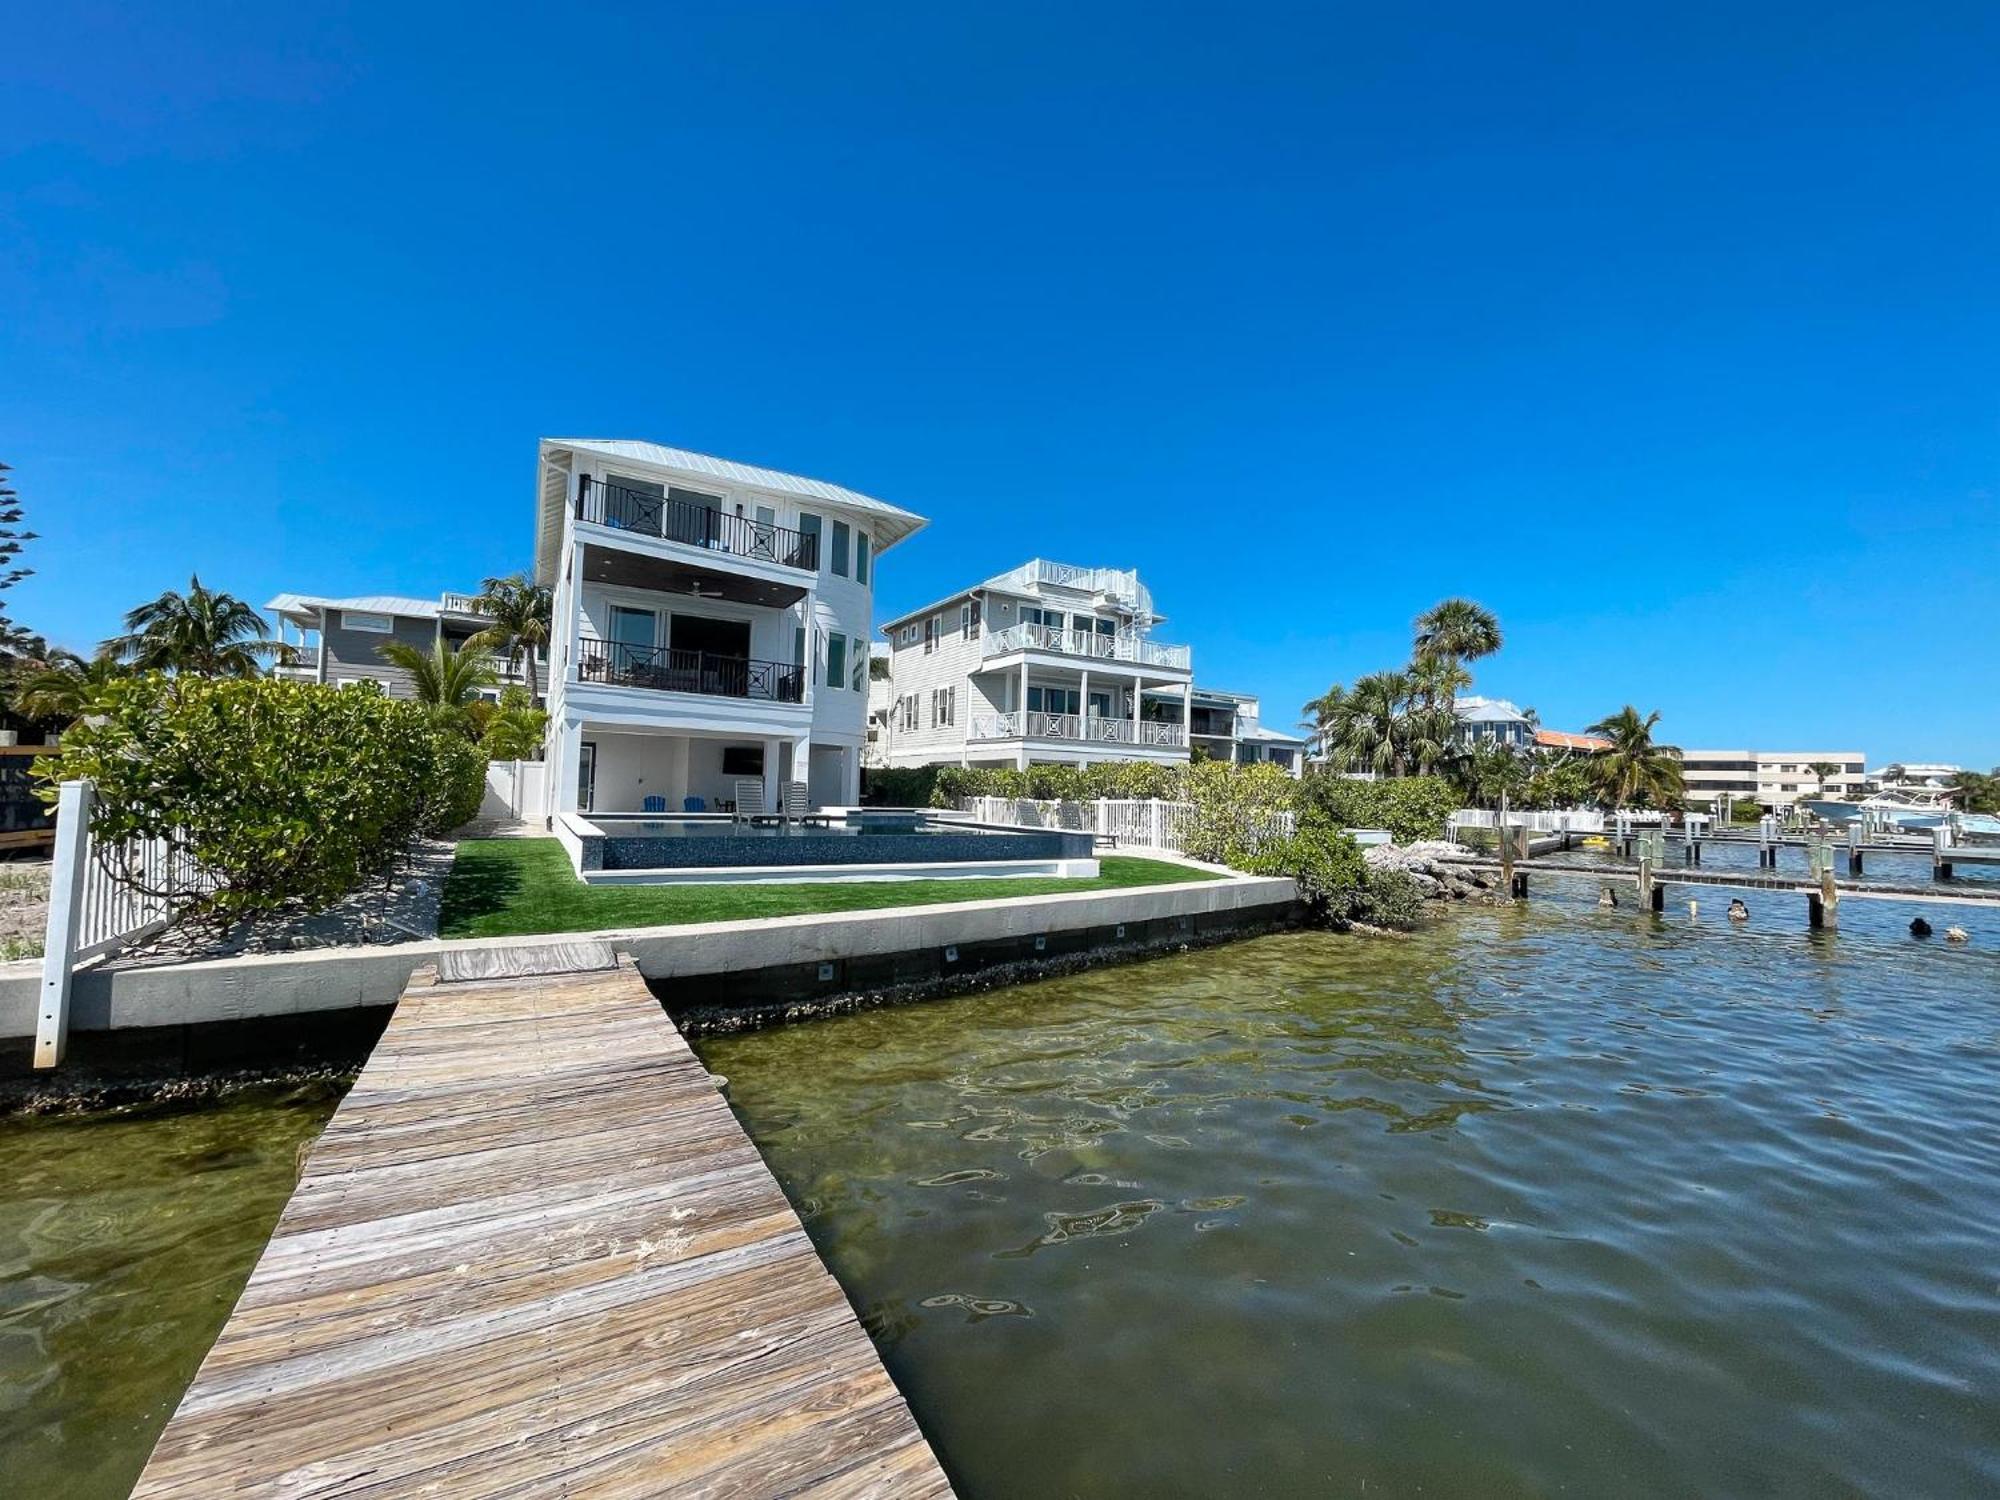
left=0, top=0, right=2000, bottom=766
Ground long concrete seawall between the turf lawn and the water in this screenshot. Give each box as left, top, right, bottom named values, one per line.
left=0, top=876, right=1296, bottom=1072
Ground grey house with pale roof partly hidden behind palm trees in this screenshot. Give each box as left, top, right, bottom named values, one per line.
left=264, top=594, right=548, bottom=698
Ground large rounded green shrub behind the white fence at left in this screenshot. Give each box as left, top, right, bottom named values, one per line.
left=40, top=674, right=486, bottom=928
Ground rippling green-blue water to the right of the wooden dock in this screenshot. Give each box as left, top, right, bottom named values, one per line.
left=702, top=900, right=2000, bottom=1500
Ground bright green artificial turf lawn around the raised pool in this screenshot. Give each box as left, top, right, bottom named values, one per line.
left=438, top=838, right=1216, bottom=938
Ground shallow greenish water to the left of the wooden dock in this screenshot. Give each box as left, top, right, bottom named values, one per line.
left=0, top=1088, right=338, bottom=1500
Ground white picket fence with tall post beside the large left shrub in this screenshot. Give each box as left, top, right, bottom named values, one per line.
left=34, top=782, right=216, bottom=1068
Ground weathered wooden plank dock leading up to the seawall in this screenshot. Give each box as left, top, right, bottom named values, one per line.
left=134, top=944, right=950, bottom=1500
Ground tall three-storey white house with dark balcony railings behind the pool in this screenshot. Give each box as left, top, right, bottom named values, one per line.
left=534, top=438, right=924, bottom=814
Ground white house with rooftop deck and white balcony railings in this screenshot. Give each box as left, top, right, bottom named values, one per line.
left=882, top=558, right=1194, bottom=766
